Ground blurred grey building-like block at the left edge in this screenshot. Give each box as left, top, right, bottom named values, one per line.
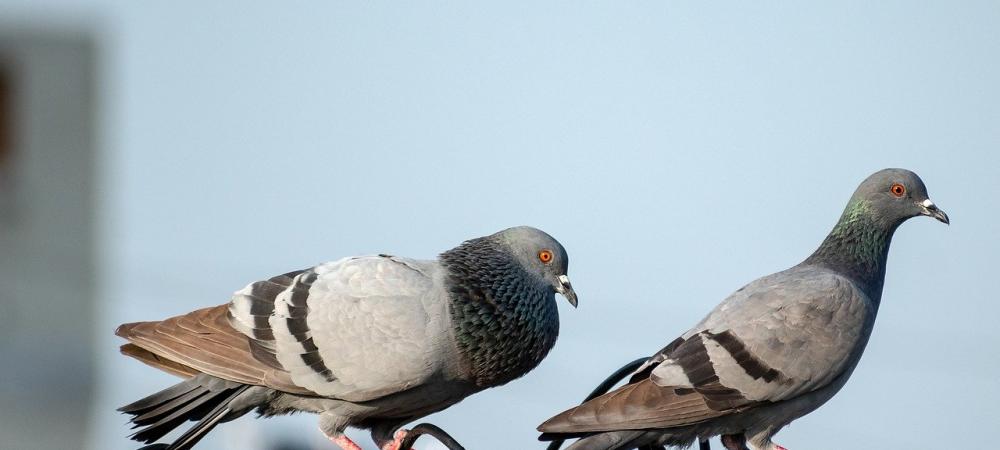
left=0, top=22, right=97, bottom=450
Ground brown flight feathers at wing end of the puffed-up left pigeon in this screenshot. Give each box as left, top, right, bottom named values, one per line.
left=115, top=305, right=315, bottom=395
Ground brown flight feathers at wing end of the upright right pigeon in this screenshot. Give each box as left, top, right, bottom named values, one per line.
left=538, top=378, right=750, bottom=433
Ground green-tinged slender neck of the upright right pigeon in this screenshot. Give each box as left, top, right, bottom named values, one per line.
left=803, top=200, right=898, bottom=302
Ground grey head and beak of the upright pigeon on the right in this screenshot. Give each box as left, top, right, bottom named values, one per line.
left=848, top=169, right=949, bottom=228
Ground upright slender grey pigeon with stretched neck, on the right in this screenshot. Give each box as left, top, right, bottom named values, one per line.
left=538, top=169, right=948, bottom=450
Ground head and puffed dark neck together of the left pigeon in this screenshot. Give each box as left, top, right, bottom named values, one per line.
left=440, top=227, right=576, bottom=388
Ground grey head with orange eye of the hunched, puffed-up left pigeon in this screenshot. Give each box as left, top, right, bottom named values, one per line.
left=488, top=226, right=577, bottom=307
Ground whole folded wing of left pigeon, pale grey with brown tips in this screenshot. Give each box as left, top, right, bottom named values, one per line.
left=119, top=255, right=447, bottom=401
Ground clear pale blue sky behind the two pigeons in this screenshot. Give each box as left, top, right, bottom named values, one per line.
left=7, top=0, right=1000, bottom=450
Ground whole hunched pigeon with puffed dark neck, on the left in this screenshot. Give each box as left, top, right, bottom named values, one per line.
left=116, top=227, right=577, bottom=450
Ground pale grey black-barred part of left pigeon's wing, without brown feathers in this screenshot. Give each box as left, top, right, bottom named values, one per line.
left=230, top=255, right=450, bottom=402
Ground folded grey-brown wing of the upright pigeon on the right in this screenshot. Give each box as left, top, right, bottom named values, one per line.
left=539, top=268, right=874, bottom=433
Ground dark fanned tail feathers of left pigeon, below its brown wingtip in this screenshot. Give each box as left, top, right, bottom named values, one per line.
left=118, top=375, right=250, bottom=450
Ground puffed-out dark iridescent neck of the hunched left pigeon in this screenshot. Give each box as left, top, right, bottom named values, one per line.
left=441, top=238, right=559, bottom=388
